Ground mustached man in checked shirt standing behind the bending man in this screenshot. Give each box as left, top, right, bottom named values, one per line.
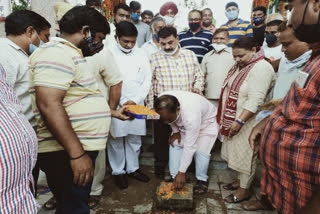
left=146, top=27, right=204, bottom=178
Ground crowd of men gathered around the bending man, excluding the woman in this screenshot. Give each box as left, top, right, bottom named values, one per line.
left=0, top=0, right=320, bottom=214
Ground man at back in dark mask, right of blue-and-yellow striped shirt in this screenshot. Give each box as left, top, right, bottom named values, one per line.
left=252, top=6, right=267, bottom=46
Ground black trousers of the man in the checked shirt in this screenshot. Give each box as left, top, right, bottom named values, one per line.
left=154, top=120, right=172, bottom=168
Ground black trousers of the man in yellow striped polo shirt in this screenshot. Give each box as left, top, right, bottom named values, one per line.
left=38, top=151, right=98, bottom=214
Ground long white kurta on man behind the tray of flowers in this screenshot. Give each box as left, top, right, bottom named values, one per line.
left=111, top=45, right=151, bottom=137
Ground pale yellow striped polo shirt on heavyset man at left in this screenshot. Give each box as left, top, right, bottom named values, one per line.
left=29, top=38, right=111, bottom=153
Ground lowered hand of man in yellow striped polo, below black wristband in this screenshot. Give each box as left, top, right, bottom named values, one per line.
left=70, top=154, right=94, bottom=186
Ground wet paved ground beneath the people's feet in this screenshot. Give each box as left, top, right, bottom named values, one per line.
left=38, top=137, right=276, bottom=214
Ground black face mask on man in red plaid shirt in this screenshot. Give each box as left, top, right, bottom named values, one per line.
left=294, top=1, right=320, bottom=44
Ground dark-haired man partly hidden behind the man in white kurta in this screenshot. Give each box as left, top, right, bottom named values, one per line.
left=103, top=3, right=131, bottom=49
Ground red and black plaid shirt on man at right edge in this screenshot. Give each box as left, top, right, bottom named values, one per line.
left=260, top=43, right=320, bottom=214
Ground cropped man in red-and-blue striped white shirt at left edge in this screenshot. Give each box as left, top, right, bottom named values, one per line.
left=0, top=64, right=38, bottom=214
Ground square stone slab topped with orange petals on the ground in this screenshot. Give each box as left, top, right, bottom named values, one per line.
left=156, top=182, right=194, bottom=211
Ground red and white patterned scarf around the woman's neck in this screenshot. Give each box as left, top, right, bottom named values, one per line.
left=217, top=49, right=264, bottom=136
